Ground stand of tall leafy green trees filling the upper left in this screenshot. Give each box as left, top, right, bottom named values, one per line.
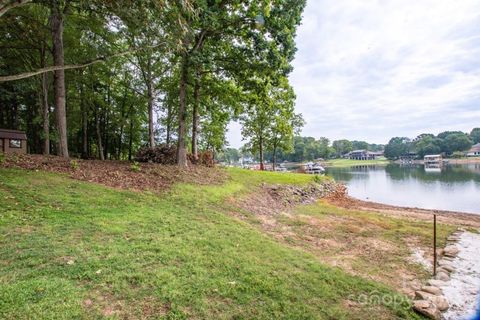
left=0, top=0, right=305, bottom=166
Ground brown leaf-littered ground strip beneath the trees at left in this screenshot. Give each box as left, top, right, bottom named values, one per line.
left=0, top=155, right=227, bottom=191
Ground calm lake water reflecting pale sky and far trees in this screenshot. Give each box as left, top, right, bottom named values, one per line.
left=327, top=163, right=480, bottom=214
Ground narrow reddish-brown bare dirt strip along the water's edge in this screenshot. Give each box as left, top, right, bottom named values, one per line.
left=327, top=195, right=480, bottom=228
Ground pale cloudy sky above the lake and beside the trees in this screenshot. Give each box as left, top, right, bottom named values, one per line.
left=227, top=0, right=480, bottom=147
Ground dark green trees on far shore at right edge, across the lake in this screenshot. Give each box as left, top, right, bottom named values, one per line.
left=385, top=128, right=480, bottom=160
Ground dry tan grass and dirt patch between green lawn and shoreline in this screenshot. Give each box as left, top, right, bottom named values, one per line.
left=236, top=183, right=434, bottom=296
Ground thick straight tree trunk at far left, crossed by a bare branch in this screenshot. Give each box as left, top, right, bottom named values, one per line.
left=51, top=0, right=68, bottom=158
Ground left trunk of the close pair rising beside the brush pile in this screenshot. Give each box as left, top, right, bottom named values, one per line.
left=177, top=54, right=188, bottom=167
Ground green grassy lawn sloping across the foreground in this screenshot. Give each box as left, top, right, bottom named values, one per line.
left=0, top=169, right=416, bottom=319
